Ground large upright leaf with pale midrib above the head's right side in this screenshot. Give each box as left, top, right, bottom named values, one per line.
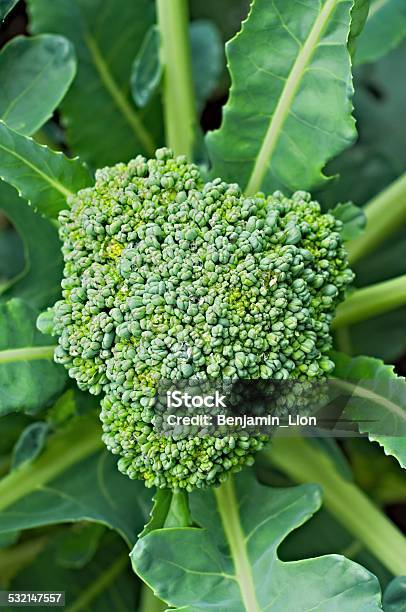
left=207, top=0, right=356, bottom=194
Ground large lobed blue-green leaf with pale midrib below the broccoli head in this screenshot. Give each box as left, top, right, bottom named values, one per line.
left=131, top=471, right=381, bottom=612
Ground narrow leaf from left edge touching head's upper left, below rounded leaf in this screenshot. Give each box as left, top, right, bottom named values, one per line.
left=0, top=121, right=91, bottom=217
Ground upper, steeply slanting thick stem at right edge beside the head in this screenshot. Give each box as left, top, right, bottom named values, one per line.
left=348, top=173, right=406, bottom=264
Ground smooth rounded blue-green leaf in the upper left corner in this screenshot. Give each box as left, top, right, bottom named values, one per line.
left=0, top=34, right=76, bottom=136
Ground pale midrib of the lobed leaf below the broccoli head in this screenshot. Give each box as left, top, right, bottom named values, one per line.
left=214, top=477, right=261, bottom=612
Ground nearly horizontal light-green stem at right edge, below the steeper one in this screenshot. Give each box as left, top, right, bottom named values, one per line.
left=332, top=274, right=406, bottom=328
